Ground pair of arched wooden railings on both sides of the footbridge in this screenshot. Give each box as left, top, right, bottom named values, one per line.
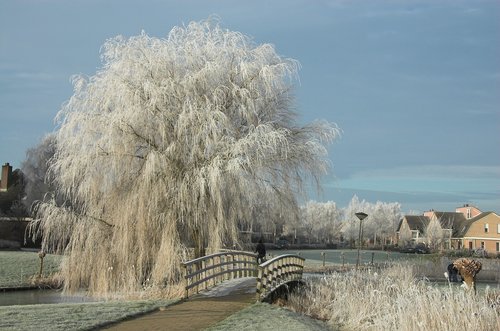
left=182, top=250, right=305, bottom=301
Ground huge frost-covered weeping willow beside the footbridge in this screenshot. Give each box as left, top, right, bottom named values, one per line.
left=36, top=20, right=338, bottom=293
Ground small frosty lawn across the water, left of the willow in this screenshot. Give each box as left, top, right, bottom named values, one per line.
left=0, top=251, right=62, bottom=288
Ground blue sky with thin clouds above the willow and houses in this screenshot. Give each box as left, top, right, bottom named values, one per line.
left=0, top=0, right=500, bottom=213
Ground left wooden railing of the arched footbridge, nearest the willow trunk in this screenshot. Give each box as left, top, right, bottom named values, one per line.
left=182, top=250, right=257, bottom=298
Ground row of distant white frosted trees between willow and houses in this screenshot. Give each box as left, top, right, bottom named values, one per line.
left=244, top=196, right=401, bottom=246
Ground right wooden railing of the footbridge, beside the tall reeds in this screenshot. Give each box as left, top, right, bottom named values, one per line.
left=256, top=254, right=305, bottom=301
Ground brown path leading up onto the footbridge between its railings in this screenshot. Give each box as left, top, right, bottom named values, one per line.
left=105, top=278, right=256, bottom=331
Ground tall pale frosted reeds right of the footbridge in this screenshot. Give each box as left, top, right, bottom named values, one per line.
left=288, top=263, right=500, bottom=331
